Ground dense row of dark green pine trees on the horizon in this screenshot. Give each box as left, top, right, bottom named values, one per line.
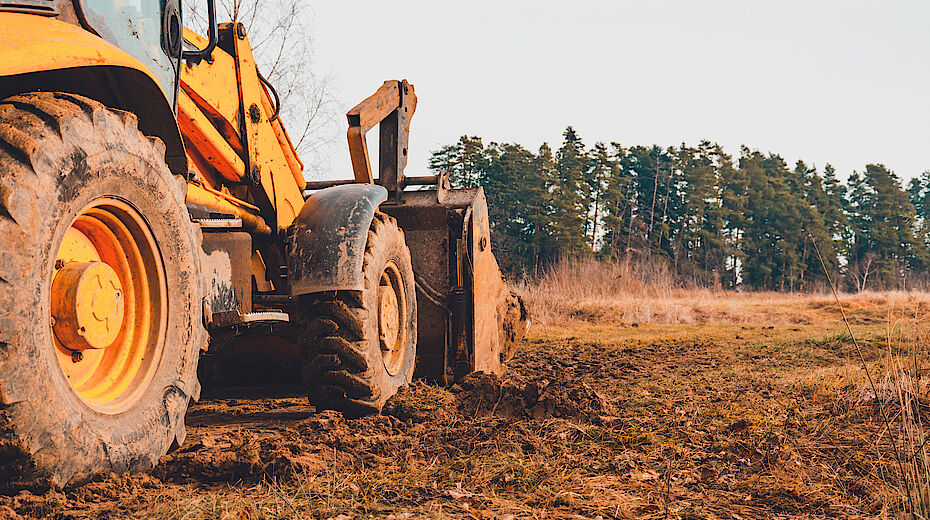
left=430, top=127, right=930, bottom=291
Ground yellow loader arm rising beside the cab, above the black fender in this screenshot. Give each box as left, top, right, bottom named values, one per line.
left=178, top=24, right=306, bottom=230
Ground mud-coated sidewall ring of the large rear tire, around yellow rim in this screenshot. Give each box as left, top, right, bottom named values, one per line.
left=0, top=126, right=202, bottom=485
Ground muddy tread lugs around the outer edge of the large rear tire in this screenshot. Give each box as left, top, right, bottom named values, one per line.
left=0, top=92, right=207, bottom=489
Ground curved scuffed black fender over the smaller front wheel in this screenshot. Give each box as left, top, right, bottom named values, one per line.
left=287, top=184, right=388, bottom=297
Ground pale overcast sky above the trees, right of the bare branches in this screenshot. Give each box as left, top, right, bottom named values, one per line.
left=313, top=0, right=930, bottom=183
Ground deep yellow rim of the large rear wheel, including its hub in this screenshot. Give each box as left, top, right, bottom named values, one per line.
left=50, top=198, right=168, bottom=414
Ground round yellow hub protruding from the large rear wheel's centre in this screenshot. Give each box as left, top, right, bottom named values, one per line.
left=52, top=262, right=125, bottom=351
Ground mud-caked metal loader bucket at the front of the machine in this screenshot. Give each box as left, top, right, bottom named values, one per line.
left=381, top=185, right=527, bottom=384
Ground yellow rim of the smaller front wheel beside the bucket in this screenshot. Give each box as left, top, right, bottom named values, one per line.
left=378, top=260, right=408, bottom=376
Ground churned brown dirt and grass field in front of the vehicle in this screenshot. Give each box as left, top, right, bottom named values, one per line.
left=0, top=297, right=916, bottom=520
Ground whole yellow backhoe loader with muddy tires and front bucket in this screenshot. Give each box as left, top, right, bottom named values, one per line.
left=0, top=0, right=526, bottom=488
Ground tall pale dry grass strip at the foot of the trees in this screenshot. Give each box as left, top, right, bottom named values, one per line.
left=516, top=260, right=930, bottom=326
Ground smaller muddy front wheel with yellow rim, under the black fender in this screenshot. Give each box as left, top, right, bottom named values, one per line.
left=298, top=213, right=417, bottom=416
